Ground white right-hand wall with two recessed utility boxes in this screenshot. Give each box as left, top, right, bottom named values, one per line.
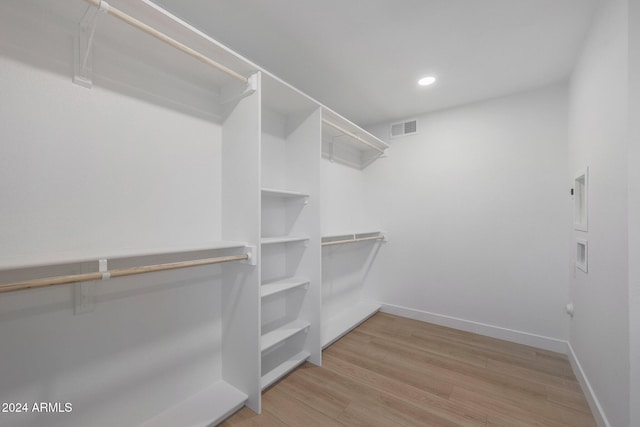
left=569, top=0, right=631, bottom=426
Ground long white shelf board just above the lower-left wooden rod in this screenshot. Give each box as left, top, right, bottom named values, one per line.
left=0, top=241, right=247, bottom=270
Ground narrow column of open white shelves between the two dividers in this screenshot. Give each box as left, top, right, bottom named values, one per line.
left=260, top=76, right=322, bottom=389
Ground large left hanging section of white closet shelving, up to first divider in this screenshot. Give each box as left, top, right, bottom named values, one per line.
left=0, top=0, right=261, bottom=427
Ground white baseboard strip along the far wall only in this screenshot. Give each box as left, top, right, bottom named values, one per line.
left=380, top=304, right=567, bottom=354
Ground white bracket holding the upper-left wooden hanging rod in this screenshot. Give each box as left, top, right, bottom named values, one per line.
left=72, top=1, right=109, bottom=89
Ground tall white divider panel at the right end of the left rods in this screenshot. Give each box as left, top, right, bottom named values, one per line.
left=222, top=73, right=261, bottom=413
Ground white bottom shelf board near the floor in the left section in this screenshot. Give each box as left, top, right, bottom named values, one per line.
left=140, top=381, right=247, bottom=427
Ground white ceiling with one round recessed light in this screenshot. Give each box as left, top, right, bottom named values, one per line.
left=151, top=0, right=601, bottom=125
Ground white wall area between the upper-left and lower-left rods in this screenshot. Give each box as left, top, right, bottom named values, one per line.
left=0, top=58, right=220, bottom=266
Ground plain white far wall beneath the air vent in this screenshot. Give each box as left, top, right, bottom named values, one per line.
left=365, top=86, right=570, bottom=350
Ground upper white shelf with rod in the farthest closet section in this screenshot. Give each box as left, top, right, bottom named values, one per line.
left=322, top=108, right=389, bottom=169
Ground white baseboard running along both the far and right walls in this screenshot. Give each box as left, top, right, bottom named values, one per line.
left=380, top=304, right=611, bottom=427
